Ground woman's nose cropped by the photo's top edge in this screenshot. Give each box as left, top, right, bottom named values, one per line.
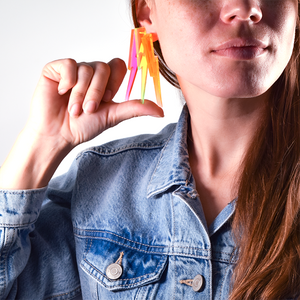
left=221, top=0, right=262, bottom=24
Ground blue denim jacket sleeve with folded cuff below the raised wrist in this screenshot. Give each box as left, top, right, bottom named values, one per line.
left=0, top=161, right=81, bottom=300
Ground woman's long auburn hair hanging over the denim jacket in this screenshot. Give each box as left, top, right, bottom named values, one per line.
left=131, top=0, right=300, bottom=300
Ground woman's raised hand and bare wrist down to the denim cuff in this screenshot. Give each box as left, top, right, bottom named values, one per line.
left=0, top=59, right=163, bottom=189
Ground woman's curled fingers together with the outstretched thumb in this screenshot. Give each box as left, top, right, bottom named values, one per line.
left=44, top=59, right=163, bottom=127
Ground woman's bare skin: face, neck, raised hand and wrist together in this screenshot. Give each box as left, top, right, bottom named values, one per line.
left=0, top=0, right=297, bottom=224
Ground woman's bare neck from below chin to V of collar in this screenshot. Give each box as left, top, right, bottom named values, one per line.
left=183, top=84, right=268, bottom=225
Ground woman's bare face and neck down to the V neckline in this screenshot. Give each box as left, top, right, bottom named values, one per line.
left=139, top=0, right=298, bottom=225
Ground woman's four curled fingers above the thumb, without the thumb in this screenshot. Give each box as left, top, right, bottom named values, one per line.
left=54, top=59, right=127, bottom=117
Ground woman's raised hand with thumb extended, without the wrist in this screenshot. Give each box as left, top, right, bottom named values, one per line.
left=26, top=59, right=163, bottom=147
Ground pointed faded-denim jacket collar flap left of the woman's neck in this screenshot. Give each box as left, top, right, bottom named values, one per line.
left=147, top=105, right=191, bottom=198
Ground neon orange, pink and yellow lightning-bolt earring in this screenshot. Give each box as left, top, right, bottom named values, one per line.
left=126, top=27, right=162, bottom=107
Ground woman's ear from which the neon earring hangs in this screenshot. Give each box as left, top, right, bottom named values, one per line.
left=135, top=0, right=158, bottom=42
